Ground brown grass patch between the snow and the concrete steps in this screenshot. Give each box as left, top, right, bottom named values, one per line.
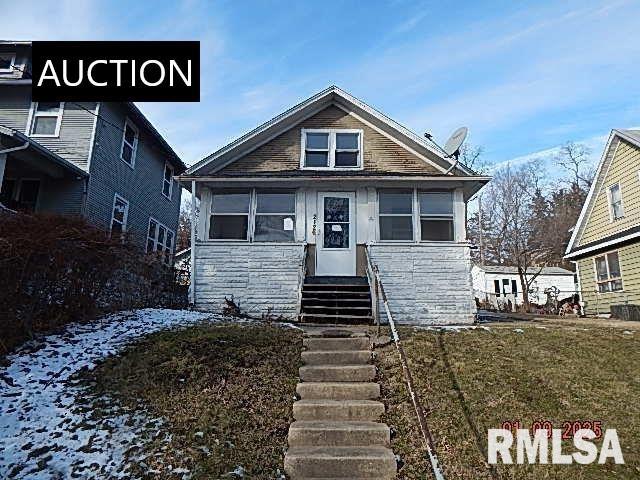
left=83, top=325, right=302, bottom=479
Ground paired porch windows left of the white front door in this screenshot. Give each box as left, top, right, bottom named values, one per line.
left=209, top=189, right=296, bottom=242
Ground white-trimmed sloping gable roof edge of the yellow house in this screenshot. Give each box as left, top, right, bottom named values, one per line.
left=565, top=129, right=640, bottom=258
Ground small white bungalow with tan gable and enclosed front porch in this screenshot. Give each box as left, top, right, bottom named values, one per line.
left=179, top=87, right=489, bottom=324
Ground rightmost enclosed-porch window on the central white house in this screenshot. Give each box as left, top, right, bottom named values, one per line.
left=418, top=192, right=453, bottom=241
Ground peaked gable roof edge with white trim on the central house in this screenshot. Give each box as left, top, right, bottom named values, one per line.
left=185, top=85, right=475, bottom=175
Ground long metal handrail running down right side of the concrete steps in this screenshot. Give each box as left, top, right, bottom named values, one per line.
left=365, top=245, right=445, bottom=480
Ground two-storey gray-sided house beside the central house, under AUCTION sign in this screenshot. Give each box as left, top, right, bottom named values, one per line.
left=0, top=41, right=186, bottom=258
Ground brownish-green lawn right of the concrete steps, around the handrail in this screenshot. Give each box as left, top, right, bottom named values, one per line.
left=377, top=320, right=640, bottom=480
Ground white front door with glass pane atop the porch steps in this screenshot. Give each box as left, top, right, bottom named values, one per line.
left=316, top=192, right=356, bottom=276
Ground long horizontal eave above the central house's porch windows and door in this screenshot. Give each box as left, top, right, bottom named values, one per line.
left=177, top=171, right=491, bottom=201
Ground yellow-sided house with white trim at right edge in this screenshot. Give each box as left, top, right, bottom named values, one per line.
left=565, top=130, right=640, bottom=315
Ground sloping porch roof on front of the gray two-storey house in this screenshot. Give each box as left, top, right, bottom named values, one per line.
left=0, top=125, right=89, bottom=178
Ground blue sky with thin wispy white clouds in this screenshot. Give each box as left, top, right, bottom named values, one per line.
left=5, top=0, right=640, bottom=172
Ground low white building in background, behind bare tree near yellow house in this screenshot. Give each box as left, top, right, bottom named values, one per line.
left=471, top=265, right=577, bottom=307
